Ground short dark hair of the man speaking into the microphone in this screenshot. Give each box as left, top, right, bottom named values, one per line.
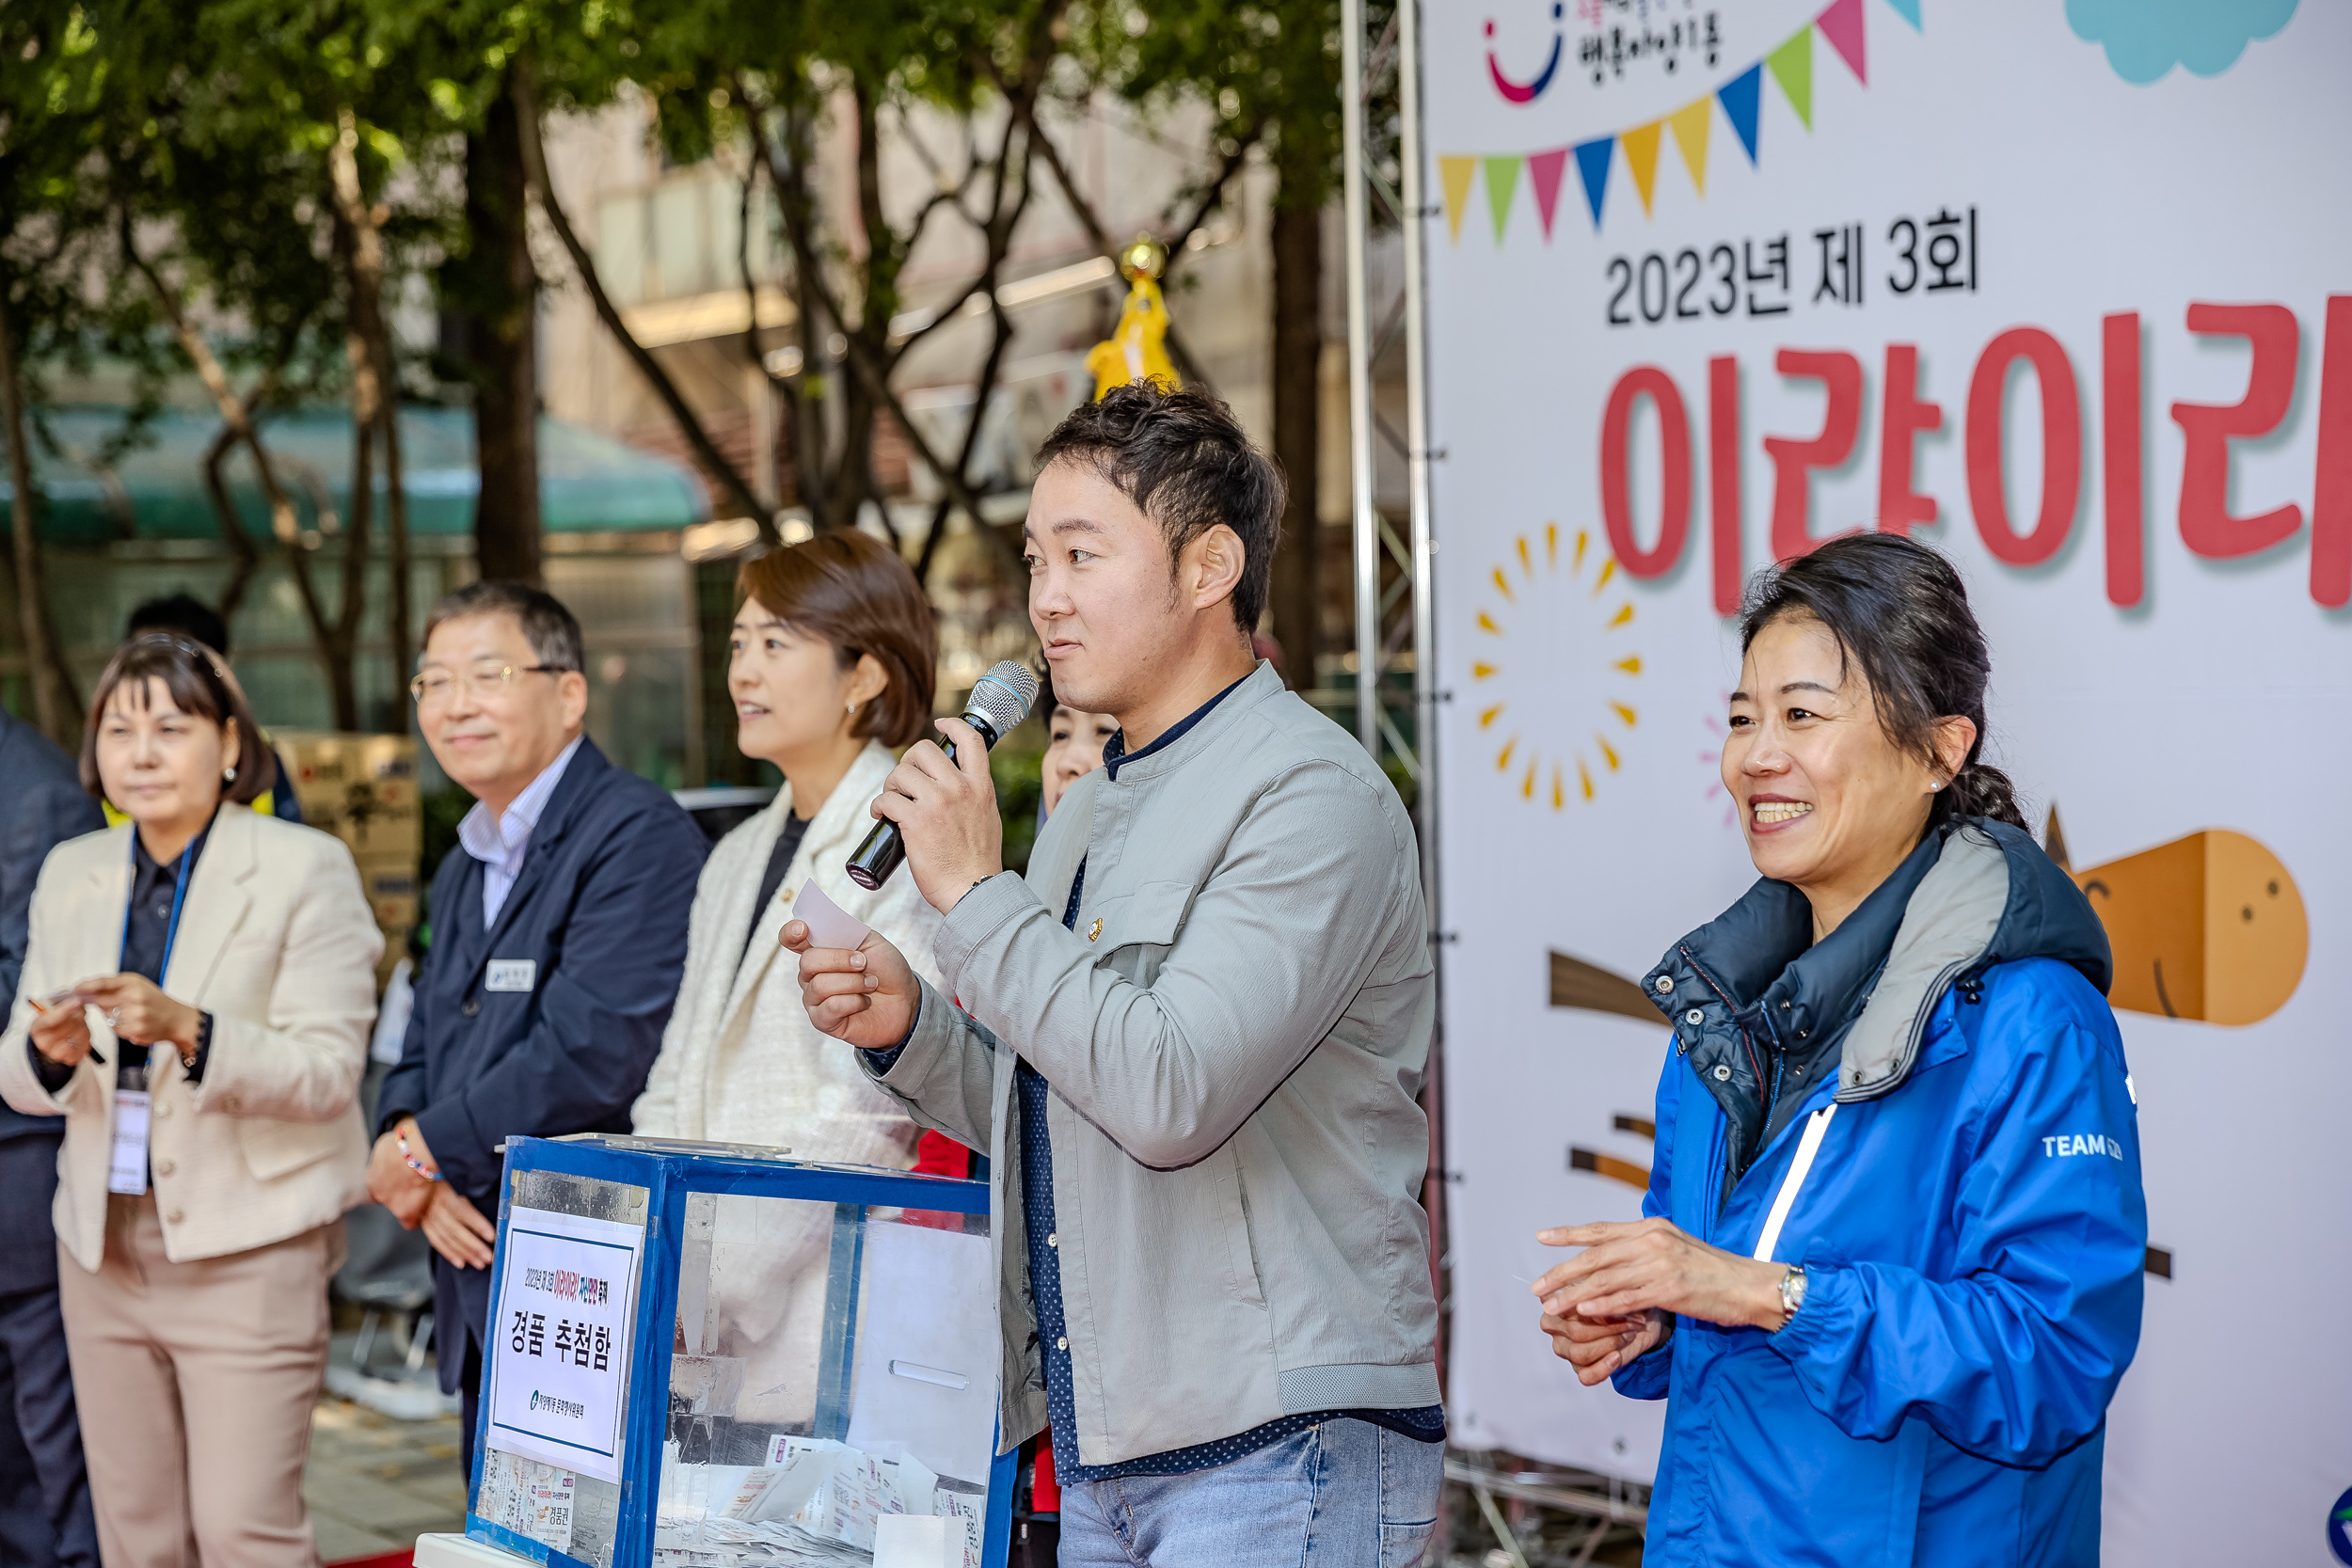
left=1038, top=378, right=1289, bottom=635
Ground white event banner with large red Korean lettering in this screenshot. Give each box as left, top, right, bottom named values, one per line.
left=1423, top=0, right=2352, bottom=1566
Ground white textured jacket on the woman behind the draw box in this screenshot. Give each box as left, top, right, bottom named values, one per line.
left=630, top=743, right=939, bottom=1171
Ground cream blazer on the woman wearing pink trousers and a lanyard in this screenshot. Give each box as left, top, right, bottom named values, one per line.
left=0, top=809, right=384, bottom=1275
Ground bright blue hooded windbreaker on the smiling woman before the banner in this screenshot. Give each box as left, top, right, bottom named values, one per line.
left=1616, top=823, right=2148, bottom=1568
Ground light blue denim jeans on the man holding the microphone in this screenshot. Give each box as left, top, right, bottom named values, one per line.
left=1058, top=1418, right=1447, bottom=1568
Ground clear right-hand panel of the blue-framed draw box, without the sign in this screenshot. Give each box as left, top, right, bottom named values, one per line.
left=654, top=1192, right=997, bottom=1568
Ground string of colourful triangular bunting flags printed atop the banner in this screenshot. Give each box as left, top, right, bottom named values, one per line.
left=1438, top=0, right=1924, bottom=245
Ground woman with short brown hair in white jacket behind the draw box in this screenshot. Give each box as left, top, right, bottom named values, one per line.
left=630, top=531, right=939, bottom=1422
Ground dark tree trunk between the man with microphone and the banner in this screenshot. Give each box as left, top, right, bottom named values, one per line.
left=1270, top=181, right=1322, bottom=691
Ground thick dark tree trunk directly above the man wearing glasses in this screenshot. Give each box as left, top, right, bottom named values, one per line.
left=464, top=79, right=544, bottom=583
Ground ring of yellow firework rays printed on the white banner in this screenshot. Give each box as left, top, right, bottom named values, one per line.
left=1470, top=522, right=1642, bottom=811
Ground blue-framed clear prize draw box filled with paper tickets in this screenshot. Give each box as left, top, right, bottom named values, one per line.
left=466, top=1135, right=1014, bottom=1568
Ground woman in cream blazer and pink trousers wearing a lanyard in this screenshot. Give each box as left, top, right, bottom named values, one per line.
left=0, top=637, right=384, bottom=1568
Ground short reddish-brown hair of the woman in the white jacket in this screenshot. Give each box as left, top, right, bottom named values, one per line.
left=737, top=529, right=939, bottom=745
